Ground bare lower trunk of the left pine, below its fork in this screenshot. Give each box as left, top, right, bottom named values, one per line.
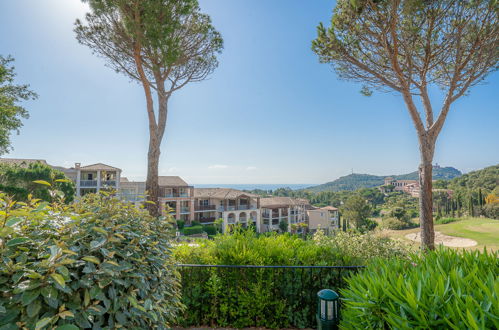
left=146, top=132, right=161, bottom=216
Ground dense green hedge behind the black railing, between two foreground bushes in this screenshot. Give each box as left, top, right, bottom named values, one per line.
left=174, top=230, right=406, bottom=328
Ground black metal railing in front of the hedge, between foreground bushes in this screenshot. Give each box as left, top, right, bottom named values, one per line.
left=177, top=264, right=364, bottom=328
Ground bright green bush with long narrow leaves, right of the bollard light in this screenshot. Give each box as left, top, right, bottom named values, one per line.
left=341, top=248, right=499, bottom=329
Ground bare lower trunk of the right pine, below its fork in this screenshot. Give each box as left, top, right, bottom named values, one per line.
left=419, top=153, right=435, bottom=250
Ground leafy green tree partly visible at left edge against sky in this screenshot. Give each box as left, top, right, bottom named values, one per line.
left=0, top=55, right=37, bottom=155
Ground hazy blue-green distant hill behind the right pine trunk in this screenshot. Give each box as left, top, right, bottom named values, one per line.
left=306, top=167, right=462, bottom=192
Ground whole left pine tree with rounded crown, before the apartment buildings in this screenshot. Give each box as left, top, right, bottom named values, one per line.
left=75, top=0, right=223, bottom=215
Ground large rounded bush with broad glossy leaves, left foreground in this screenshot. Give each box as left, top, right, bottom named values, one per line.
left=0, top=195, right=182, bottom=329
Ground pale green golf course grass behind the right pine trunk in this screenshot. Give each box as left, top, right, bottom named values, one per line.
left=382, top=218, right=499, bottom=251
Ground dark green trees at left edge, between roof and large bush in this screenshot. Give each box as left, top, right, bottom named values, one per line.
left=0, top=162, right=75, bottom=203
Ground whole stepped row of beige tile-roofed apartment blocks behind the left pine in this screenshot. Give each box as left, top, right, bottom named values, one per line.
left=0, top=158, right=338, bottom=232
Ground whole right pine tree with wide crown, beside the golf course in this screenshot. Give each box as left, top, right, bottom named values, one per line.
left=312, top=0, right=499, bottom=249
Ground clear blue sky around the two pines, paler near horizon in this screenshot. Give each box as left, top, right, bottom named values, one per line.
left=0, top=0, right=499, bottom=184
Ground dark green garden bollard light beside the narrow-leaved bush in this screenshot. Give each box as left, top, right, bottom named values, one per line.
left=317, top=289, right=340, bottom=330
